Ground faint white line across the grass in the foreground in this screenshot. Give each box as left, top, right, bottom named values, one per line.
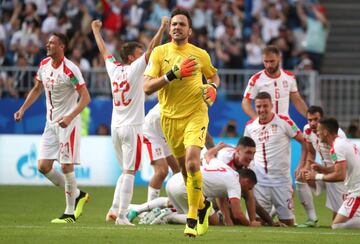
left=0, top=225, right=360, bottom=236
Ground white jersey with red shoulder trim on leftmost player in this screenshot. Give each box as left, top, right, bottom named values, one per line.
left=35, top=57, right=85, bottom=124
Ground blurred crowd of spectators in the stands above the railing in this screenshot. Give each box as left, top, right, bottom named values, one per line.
left=0, top=0, right=328, bottom=97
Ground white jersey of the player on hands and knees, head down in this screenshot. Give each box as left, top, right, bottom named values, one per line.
left=200, top=158, right=241, bottom=199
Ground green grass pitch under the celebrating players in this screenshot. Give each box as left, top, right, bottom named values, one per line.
left=0, top=186, right=360, bottom=244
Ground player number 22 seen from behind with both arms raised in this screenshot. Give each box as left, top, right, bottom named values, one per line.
left=91, top=17, right=168, bottom=225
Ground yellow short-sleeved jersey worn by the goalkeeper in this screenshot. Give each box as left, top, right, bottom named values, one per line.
left=144, top=42, right=217, bottom=119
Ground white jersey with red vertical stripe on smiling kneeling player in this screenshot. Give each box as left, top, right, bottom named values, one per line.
left=244, top=114, right=301, bottom=186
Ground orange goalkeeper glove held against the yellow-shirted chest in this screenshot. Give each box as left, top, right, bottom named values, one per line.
left=165, top=57, right=197, bottom=81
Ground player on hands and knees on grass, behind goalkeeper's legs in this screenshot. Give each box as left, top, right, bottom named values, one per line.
left=128, top=163, right=260, bottom=226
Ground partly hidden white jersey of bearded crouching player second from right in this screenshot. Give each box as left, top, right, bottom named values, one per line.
left=303, top=124, right=346, bottom=166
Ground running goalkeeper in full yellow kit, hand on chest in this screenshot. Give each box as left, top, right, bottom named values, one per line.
left=144, top=9, right=220, bottom=237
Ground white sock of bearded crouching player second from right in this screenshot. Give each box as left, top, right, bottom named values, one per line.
left=296, top=182, right=317, bottom=221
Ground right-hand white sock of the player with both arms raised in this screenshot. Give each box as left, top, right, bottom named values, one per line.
left=119, top=174, right=135, bottom=218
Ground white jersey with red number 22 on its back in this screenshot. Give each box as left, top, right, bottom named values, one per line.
left=105, top=54, right=146, bottom=127
